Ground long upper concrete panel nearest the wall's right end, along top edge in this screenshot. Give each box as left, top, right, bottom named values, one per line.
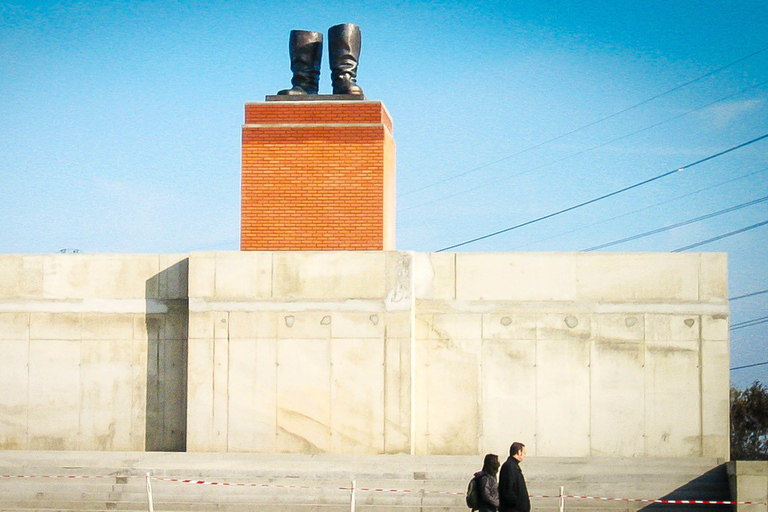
left=578, top=253, right=699, bottom=302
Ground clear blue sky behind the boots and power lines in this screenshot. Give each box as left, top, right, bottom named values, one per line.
left=0, top=0, right=768, bottom=387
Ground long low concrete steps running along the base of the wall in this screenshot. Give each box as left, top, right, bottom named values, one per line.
left=0, top=451, right=730, bottom=512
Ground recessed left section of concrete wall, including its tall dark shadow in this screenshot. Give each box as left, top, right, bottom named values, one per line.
left=0, top=254, right=187, bottom=450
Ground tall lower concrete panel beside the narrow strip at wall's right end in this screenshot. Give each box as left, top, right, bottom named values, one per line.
left=645, top=341, right=702, bottom=457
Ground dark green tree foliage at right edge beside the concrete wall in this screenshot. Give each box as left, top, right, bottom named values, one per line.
left=731, top=381, right=768, bottom=460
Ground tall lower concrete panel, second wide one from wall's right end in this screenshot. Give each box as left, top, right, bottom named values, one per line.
left=590, top=338, right=645, bottom=457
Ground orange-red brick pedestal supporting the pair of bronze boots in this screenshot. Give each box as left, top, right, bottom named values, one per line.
left=240, top=101, right=395, bottom=251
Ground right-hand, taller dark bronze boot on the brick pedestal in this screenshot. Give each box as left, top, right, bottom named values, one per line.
left=328, top=23, right=363, bottom=96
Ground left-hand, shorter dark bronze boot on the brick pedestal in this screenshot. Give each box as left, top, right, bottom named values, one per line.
left=277, top=30, right=323, bottom=96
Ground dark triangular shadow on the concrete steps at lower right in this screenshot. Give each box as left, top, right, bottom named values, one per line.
left=640, top=464, right=735, bottom=512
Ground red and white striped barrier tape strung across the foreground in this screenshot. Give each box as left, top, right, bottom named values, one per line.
left=0, top=475, right=766, bottom=505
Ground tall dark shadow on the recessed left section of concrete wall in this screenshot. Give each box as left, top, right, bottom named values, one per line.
left=145, top=258, right=189, bottom=452
